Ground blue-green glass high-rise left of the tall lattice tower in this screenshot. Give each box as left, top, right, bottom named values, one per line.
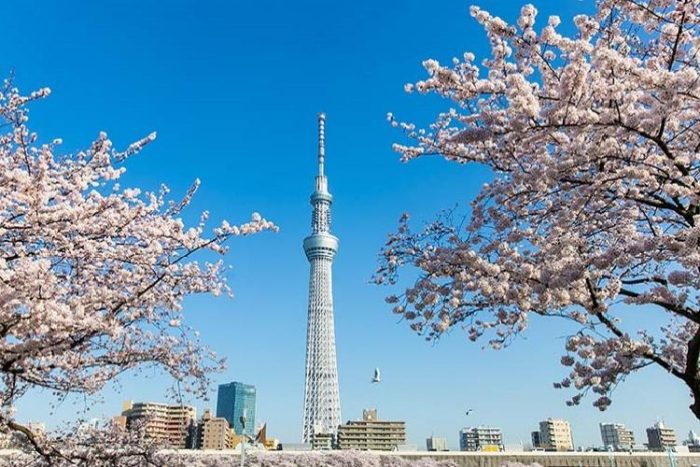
left=216, top=381, right=255, bottom=436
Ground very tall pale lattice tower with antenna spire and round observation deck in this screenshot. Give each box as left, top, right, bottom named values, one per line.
left=303, top=114, right=340, bottom=442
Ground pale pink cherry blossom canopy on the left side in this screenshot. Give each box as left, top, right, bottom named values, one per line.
left=0, top=82, right=275, bottom=460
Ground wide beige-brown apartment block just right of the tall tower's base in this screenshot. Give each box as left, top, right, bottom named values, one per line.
left=338, top=409, right=406, bottom=451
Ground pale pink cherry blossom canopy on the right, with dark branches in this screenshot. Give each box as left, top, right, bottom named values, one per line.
left=375, top=0, right=700, bottom=418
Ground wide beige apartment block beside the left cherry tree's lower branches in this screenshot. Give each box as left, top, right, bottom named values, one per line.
left=114, top=401, right=197, bottom=449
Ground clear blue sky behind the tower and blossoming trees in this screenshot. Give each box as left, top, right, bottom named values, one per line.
left=0, top=0, right=698, bottom=448
